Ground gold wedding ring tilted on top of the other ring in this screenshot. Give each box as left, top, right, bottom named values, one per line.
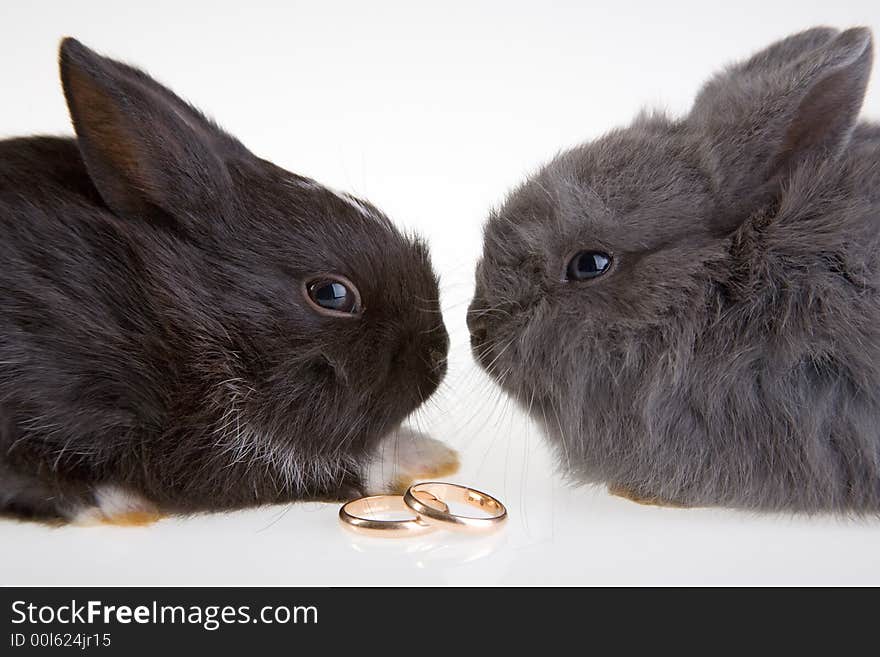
left=403, top=481, right=507, bottom=532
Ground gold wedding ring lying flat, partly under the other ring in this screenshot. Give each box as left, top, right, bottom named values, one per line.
left=339, top=493, right=449, bottom=537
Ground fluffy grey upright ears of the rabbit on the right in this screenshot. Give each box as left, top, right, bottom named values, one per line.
left=688, top=27, right=873, bottom=230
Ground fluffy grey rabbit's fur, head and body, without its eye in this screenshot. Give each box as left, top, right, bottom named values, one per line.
left=468, top=28, right=880, bottom=514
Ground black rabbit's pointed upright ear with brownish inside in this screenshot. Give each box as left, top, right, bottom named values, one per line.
left=60, top=38, right=243, bottom=228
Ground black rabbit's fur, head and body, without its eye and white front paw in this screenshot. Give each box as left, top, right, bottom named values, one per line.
left=0, top=40, right=448, bottom=518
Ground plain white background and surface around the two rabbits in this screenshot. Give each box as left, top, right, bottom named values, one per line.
left=0, top=0, right=880, bottom=584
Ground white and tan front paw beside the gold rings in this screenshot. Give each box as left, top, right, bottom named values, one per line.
left=366, top=429, right=459, bottom=495
